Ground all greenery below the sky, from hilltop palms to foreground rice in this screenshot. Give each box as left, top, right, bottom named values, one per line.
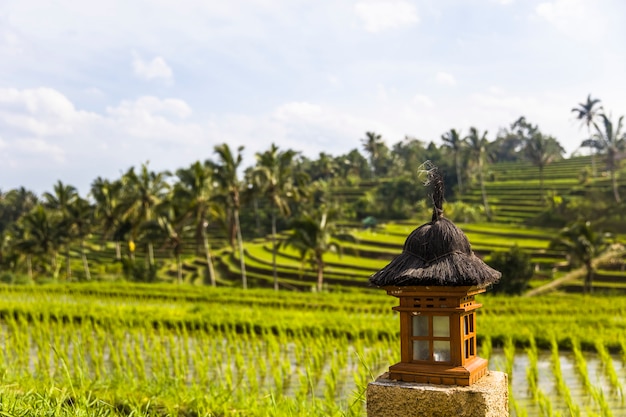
left=0, top=97, right=626, bottom=416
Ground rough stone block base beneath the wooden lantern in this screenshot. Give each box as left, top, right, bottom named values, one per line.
left=367, top=371, right=509, bottom=417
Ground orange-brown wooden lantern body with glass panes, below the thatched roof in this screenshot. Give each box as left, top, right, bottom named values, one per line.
left=385, top=286, right=487, bottom=386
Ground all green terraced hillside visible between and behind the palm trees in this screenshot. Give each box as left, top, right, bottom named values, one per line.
left=2, top=157, right=626, bottom=292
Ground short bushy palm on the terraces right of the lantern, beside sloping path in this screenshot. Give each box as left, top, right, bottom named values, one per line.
left=550, top=221, right=608, bottom=293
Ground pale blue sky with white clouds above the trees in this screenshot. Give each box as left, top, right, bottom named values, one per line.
left=0, top=0, right=626, bottom=195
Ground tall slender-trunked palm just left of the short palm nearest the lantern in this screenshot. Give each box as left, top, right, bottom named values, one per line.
left=255, top=143, right=299, bottom=291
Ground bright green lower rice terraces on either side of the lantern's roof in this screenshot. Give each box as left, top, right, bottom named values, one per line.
left=223, top=221, right=626, bottom=292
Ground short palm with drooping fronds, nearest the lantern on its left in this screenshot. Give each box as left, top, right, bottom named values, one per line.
left=284, top=205, right=338, bottom=291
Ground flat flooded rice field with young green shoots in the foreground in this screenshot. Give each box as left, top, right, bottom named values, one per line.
left=0, top=284, right=626, bottom=416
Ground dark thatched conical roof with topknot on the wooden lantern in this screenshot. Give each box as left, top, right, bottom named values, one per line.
left=370, top=164, right=501, bottom=288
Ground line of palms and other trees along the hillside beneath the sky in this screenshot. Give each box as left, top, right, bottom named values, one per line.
left=0, top=96, right=626, bottom=289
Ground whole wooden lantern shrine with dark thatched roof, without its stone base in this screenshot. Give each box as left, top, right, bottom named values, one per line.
left=370, top=164, right=501, bottom=386
